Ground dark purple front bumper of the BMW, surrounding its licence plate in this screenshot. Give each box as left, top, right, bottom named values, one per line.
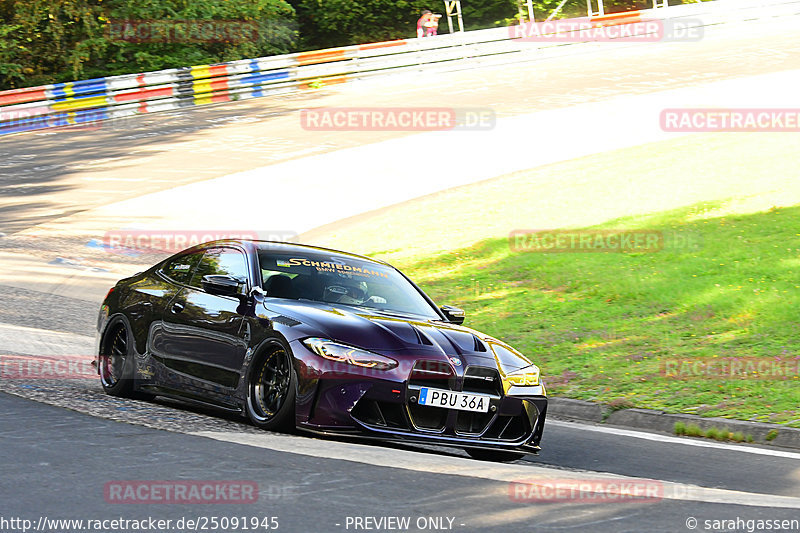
left=293, top=340, right=547, bottom=453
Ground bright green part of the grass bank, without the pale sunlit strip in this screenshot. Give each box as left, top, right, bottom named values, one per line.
left=400, top=204, right=800, bottom=425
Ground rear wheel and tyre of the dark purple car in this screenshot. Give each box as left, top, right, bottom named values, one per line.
left=97, top=322, right=136, bottom=398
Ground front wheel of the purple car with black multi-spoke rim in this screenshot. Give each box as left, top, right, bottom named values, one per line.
left=246, top=346, right=297, bottom=431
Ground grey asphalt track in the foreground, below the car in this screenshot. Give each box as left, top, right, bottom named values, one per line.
left=0, top=388, right=800, bottom=532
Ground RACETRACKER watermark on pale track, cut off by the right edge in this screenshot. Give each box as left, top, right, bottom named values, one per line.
left=660, top=108, right=800, bottom=133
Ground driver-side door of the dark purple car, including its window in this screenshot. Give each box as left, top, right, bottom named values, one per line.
left=161, top=246, right=250, bottom=404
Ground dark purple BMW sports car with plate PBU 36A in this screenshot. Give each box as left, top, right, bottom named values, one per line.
left=97, top=240, right=547, bottom=460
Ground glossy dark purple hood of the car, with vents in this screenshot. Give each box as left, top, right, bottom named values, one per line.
left=265, top=299, right=532, bottom=372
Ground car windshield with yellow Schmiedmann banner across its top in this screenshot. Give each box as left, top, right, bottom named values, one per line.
left=258, top=249, right=441, bottom=319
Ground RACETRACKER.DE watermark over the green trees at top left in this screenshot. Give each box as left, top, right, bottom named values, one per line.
left=105, top=19, right=260, bottom=43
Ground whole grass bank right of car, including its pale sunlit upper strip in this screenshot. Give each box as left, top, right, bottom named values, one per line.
left=310, top=134, right=800, bottom=428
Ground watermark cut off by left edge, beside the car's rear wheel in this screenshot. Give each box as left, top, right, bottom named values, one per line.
left=0, top=355, right=97, bottom=380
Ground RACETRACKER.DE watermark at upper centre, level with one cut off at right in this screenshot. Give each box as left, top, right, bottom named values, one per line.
left=300, top=107, right=497, bottom=131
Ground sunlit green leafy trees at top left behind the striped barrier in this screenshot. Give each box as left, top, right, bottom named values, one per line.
left=0, top=0, right=297, bottom=89
